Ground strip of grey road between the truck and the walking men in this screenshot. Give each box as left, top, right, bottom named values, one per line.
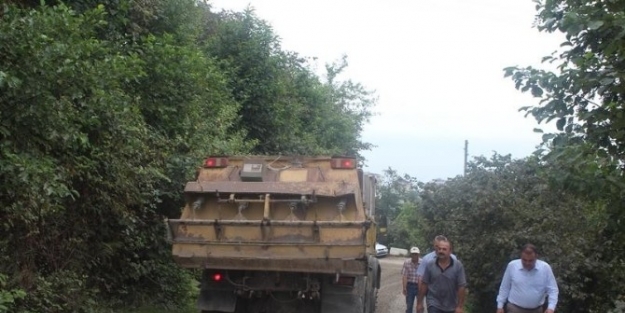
left=375, top=256, right=416, bottom=313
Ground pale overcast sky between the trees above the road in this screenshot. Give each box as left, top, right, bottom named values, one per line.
left=210, top=0, right=564, bottom=181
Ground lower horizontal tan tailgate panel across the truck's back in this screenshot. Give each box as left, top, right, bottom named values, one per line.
left=168, top=220, right=371, bottom=274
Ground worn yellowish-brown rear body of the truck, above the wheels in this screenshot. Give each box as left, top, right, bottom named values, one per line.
left=168, top=157, right=375, bottom=275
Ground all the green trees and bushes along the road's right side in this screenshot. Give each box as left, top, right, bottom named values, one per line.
left=378, top=0, right=625, bottom=313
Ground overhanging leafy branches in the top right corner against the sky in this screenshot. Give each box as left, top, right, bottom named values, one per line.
left=505, top=0, right=625, bottom=160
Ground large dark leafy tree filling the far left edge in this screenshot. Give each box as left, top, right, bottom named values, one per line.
left=0, top=6, right=158, bottom=311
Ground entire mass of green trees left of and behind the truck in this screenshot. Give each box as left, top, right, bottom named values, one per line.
left=0, top=0, right=376, bottom=313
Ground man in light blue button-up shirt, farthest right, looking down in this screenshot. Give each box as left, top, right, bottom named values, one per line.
left=497, top=244, right=559, bottom=313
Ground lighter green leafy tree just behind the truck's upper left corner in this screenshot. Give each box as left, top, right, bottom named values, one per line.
left=126, top=31, right=252, bottom=218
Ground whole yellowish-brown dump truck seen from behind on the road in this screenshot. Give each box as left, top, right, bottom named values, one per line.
left=167, top=156, right=381, bottom=313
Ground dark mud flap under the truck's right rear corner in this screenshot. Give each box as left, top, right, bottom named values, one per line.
left=321, top=277, right=366, bottom=313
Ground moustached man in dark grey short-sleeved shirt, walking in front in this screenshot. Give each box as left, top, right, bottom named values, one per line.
left=417, top=239, right=467, bottom=313
